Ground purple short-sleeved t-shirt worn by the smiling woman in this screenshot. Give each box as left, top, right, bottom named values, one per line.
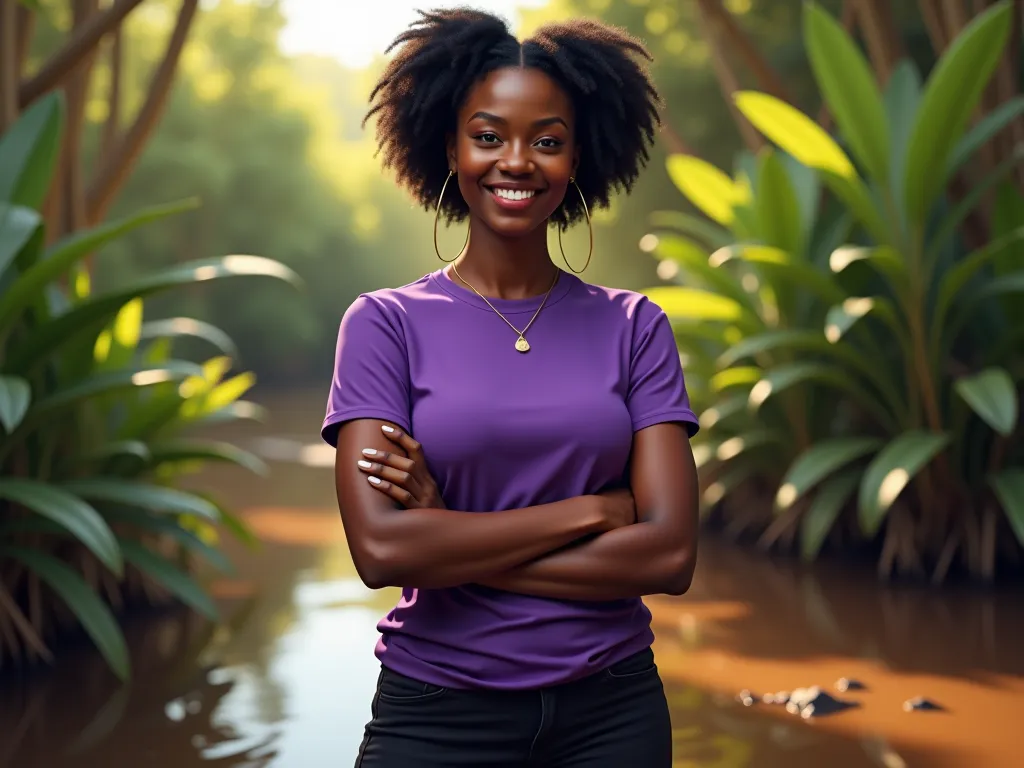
left=322, top=269, right=697, bottom=689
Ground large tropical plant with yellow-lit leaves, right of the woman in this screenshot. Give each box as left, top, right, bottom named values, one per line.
left=641, top=2, right=1024, bottom=581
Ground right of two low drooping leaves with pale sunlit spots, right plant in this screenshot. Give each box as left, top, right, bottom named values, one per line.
left=857, top=431, right=949, bottom=536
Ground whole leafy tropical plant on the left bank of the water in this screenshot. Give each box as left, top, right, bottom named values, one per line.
left=0, top=93, right=297, bottom=678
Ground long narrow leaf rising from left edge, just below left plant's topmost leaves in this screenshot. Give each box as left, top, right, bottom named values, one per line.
left=0, top=201, right=197, bottom=327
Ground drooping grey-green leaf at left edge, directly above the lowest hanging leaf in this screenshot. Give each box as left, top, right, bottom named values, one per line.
left=0, top=477, right=124, bottom=575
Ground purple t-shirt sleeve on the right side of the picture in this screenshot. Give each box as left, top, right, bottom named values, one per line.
left=626, top=301, right=698, bottom=437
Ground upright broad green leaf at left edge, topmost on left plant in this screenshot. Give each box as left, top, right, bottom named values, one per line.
left=0, top=90, right=65, bottom=210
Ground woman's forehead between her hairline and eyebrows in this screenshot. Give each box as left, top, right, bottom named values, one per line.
left=459, top=67, right=572, bottom=122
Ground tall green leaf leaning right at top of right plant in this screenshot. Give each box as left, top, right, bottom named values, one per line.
left=904, top=1, right=1013, bottom=223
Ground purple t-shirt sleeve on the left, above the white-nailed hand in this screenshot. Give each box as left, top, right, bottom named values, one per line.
left=321, top=295, right=410, bottom=447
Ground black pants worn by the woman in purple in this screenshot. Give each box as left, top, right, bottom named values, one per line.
left=355, top=649, right=672, bottom=768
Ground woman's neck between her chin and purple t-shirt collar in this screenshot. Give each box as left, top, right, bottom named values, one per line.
left=453, top=220, right=557, bottom=300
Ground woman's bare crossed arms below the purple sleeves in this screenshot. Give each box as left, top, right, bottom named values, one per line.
left=335, top=420, right=697, bottom=600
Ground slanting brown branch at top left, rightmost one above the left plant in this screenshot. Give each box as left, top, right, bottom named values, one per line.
left=87, top=0, right=199, bottom=223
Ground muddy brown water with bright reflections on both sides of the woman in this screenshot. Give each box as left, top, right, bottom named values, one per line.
left=0, top=393, right=1024, bottom=768
